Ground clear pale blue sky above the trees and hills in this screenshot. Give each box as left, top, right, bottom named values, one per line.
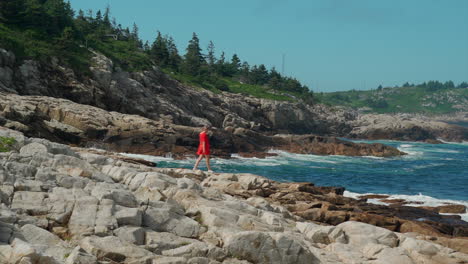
left=70, top=0, right=468, bottom=92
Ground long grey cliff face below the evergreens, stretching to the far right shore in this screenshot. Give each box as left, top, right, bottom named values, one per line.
left=0, top=49, right=468, bottom=141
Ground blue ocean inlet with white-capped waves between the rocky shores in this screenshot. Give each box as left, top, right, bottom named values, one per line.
left=122, top=140, right=468, bottom=221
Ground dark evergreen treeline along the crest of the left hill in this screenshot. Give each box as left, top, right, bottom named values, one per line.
left=0, top=0, right=312, bottom=99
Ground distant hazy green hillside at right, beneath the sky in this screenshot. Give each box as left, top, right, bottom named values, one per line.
left=316, top=81, right=468, bottom=114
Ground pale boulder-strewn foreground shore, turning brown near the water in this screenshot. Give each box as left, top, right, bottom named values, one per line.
left=0, top=128, right=468, bottom=264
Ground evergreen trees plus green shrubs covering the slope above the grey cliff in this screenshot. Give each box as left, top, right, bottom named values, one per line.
left=0, top=0, right=313, bottom=102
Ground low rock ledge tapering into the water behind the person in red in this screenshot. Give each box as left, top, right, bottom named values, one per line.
left=0, top=93, right=403, bottom=158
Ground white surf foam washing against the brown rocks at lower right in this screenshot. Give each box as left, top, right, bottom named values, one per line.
left=343, top=191, right=468, bottom=222
